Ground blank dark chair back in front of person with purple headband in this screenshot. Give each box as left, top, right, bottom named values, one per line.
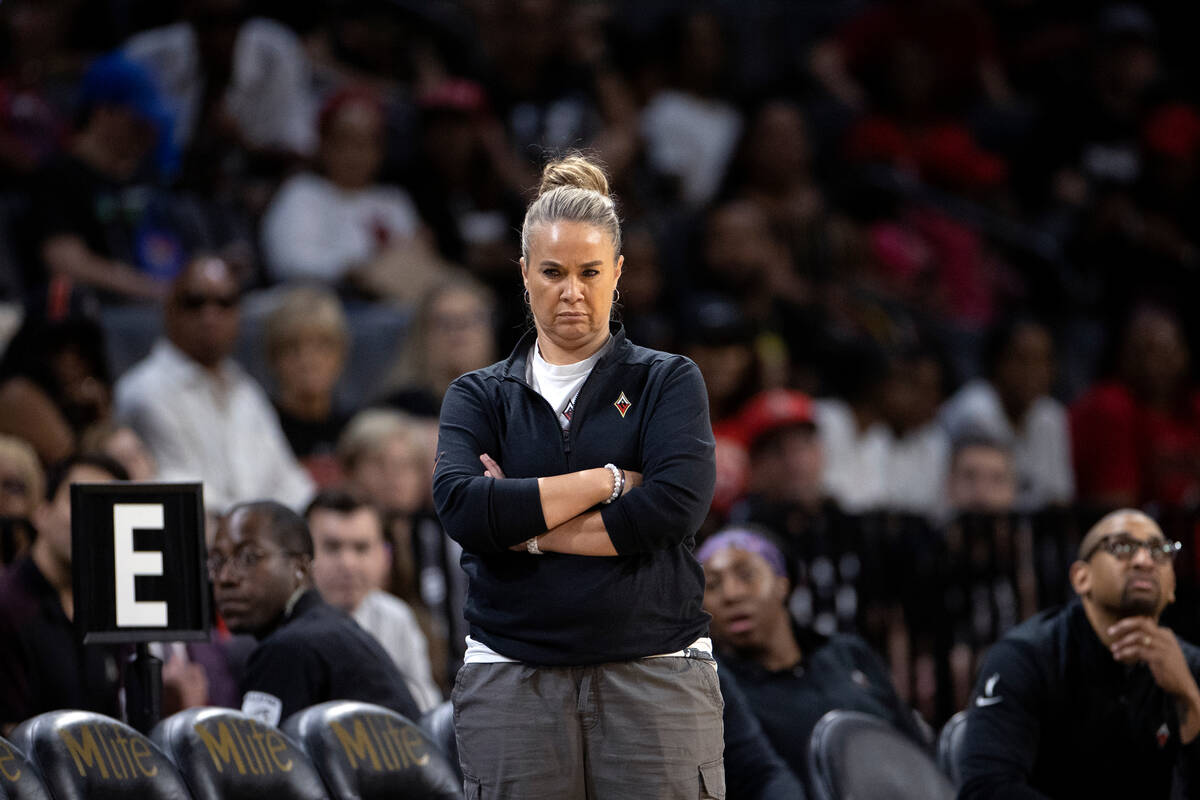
left=809, top=711, right=955, bottom=800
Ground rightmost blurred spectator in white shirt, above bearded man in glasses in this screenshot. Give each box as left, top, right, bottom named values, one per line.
left=941, top=318, right=1075, bottom=511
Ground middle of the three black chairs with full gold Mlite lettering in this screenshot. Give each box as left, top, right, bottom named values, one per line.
left=151, top=708, right=326, bottom=800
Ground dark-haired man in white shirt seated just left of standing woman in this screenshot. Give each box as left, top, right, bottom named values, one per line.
left=305, top=489, right=442, bottom=712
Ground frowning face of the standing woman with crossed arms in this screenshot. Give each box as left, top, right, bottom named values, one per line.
left=521, top=222, right=625, bottom=363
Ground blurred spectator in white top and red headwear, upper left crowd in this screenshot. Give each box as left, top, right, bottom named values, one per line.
left=262, top=89, right=434, bottom=291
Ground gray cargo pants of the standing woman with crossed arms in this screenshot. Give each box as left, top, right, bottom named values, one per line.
left=451, top=657, right=725, bottom=800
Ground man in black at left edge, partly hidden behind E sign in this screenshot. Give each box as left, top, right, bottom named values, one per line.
left=0, top=456, right=126, bottom=732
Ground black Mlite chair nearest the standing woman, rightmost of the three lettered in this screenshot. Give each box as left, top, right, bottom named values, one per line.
left=283, top=700, right=462, bottom=800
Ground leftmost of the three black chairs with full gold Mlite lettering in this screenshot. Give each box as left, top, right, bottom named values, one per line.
left=12, top=711, right=191, bottom=800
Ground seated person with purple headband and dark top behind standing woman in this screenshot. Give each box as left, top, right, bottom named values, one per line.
left=696, top=525, right=928, bottom=775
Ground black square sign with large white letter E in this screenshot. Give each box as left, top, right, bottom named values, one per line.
left=71, top=483, right=209, bottom=644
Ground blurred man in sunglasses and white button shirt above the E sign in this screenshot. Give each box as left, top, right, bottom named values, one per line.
left=115, top=257, right=313, bottom=512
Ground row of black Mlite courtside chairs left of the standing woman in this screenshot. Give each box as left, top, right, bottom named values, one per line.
left=0, top=700, right=462, bottom=800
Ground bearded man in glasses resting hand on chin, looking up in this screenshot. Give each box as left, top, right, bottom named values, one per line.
left=958, top=509, right=1200, bottom=800
